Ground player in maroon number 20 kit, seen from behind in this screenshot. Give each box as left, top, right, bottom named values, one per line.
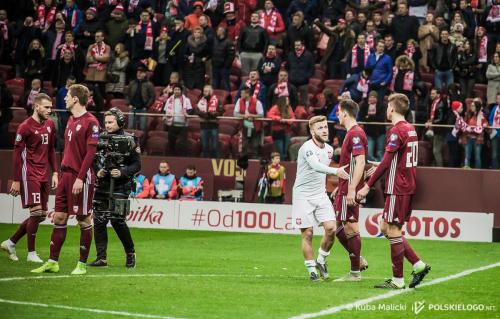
left=357, top=93, right=431, bottom=289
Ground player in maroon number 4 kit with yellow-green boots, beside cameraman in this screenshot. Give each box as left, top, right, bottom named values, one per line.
left=31, top=84, right=99, bottom=275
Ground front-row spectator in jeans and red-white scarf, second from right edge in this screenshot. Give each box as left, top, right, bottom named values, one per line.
left=464, top=98, right=488, bottom=168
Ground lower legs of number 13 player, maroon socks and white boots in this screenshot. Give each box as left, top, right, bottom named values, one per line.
left=1, top=205, right=47, bottom=263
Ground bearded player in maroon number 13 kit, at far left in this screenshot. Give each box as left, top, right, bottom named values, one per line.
left=0, top=93, right=57, bottom=263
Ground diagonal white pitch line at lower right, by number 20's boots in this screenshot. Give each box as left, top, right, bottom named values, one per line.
left=289, top=262, right=500, bottom=319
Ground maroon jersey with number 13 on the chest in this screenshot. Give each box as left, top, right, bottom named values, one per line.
left=12, top=117, right=57, bottom=182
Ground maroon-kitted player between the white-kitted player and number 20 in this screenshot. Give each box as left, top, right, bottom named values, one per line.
left=334, top=99, right=368, bottom=281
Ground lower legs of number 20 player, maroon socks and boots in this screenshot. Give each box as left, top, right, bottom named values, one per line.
left=375, top=221, right=431, bottom=289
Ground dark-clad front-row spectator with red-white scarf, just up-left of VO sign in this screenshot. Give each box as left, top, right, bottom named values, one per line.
left=195, top=85, right=224, bottom=158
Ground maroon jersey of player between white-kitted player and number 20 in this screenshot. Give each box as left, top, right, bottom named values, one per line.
left=337, top=125, right=368, bottom=195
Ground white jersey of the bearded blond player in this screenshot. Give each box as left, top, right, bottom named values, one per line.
left=293, top=139, right=337, bottom=200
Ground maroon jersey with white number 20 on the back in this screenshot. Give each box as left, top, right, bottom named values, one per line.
left=385, top=121, right=418, bottom=195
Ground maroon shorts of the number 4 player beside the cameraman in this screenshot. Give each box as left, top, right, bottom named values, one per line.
left=54, top=172, right=94, bottom=216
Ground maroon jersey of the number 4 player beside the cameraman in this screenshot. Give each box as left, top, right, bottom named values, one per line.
left=61, top=112, right=99, bottom=183
